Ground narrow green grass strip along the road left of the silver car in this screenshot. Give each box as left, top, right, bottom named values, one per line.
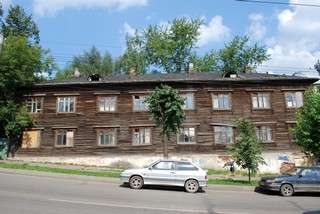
left=0, top=163, right=120, bottom=178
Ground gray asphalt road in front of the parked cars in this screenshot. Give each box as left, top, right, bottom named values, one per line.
left=0, top=169, right=320, bottom=214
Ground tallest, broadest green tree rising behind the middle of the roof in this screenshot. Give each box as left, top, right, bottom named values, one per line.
left=143, top=18, right=203, bottom=73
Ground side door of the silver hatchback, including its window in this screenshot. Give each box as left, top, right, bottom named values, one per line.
left=145, top=161, right=175, bottom=185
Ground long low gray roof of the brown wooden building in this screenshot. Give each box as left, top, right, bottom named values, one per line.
left=37, top=73, right=318, bottom=86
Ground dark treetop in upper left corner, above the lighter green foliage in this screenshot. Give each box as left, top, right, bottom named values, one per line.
left=1, top=5, right=40, bottom=44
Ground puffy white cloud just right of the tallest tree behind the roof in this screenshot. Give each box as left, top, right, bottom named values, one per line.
left=197, top=16, right=230, bottom=47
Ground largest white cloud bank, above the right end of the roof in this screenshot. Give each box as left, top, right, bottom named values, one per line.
left=259, top=0, right=320, bottom=75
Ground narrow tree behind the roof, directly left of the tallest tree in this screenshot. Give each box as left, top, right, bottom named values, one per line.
left=115, top=31, right=147, bottom=74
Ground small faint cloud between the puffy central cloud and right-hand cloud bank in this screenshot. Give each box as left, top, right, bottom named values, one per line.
left=247, top=13, right=267, bottom=40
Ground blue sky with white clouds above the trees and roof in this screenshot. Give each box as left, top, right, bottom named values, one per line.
left=1, top=0, right=320, bottom=75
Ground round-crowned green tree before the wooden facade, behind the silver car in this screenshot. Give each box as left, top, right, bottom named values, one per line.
left=145, top=85, right=186, bottom=158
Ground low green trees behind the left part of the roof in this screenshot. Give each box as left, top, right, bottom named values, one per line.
left=55, top=46, right=113, bottom=79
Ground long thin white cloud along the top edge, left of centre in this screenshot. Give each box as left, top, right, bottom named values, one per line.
left=33, top=0, right=148, bottom=17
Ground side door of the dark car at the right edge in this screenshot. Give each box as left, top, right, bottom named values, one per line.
left=296, top=168, right=319, bottom=191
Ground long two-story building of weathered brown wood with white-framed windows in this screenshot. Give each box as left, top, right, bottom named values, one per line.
left=19, top=72, right=318, bottom=171
